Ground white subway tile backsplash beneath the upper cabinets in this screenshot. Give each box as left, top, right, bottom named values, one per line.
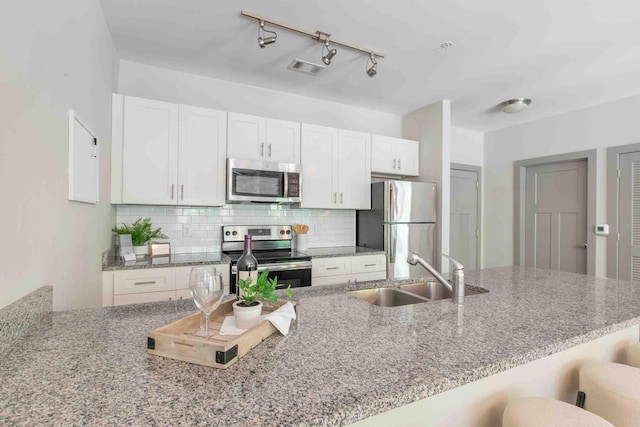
left=116, top=204, right=356, bottom=253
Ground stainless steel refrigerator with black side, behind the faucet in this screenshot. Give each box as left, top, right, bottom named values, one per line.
left=356, top=181, right=437, bottom=279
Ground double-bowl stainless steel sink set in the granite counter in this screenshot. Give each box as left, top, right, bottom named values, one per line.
left=347, top=281, right=489, bottom=307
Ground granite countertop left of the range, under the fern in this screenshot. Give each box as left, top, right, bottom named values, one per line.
left=102, top=252, right=230, bottom=271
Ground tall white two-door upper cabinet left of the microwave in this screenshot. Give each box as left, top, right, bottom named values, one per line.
left=111, top=95, right=227, bottom=206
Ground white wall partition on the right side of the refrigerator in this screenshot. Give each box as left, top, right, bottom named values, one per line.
left=402, top=99, right=451, bottom=272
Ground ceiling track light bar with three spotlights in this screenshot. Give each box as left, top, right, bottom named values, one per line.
left=240, top=10, right=384, bottom=77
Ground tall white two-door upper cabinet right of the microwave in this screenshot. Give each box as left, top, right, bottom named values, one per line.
left=300, top=124, right=371, bottom=209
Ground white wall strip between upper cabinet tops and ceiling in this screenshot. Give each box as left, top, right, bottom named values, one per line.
left=118, top=60, right=402, bottom=137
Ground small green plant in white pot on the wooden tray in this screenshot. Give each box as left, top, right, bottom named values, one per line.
left=233, top=270, right=292, bottom=329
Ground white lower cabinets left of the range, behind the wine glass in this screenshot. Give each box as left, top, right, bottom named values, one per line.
left=102, top=264, right=229, bottom=307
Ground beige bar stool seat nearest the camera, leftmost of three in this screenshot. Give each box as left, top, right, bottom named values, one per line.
left=502, top=397, right=613, bottom=427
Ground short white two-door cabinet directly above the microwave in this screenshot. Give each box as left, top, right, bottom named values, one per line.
left=227, top=113, right=300, bottom=163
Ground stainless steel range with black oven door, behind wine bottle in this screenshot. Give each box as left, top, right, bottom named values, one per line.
left=222, top=225, right=311, bottom=293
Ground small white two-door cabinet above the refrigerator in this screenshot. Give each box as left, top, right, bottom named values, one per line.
left=371, top=135, right=420, bottom=176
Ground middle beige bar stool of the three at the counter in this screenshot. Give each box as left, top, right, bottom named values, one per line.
left=578, top=363, right=640, bottom=427
